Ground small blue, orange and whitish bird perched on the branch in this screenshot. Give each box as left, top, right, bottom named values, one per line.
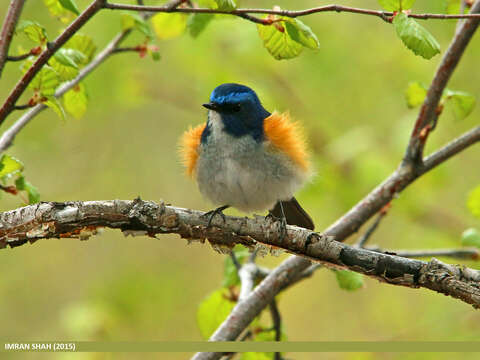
left=180, top=83, right=314, bottom=232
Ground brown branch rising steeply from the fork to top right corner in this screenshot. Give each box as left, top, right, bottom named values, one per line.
left=403, top=1, right=480, bottom=166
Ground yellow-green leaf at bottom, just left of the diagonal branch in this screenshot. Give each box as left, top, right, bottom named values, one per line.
left=197, top=288, right=235, bottom=339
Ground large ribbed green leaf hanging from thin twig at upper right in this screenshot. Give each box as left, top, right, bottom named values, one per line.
left=393, top=13, right=440, bottom=59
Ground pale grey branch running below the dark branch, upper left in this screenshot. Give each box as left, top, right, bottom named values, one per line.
left=0, top=30, right=131, bottom=152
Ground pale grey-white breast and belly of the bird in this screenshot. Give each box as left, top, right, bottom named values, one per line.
left=196, top=111, right=306, bottom=212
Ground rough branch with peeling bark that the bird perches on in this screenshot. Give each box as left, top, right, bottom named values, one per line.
left=0, top=199, right=480, bottom=308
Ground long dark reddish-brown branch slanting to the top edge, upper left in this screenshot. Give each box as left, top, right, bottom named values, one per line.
left=0, top=0, right=105, bottom=125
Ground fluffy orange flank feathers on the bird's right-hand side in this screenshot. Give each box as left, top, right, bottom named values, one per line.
left=263, top=112, right=310, bottom=171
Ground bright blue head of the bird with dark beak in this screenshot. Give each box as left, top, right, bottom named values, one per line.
left=203, top=84, right=270, bottom=141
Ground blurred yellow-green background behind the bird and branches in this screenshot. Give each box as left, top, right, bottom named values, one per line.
left=0, top=0, right=480, bottom=360
